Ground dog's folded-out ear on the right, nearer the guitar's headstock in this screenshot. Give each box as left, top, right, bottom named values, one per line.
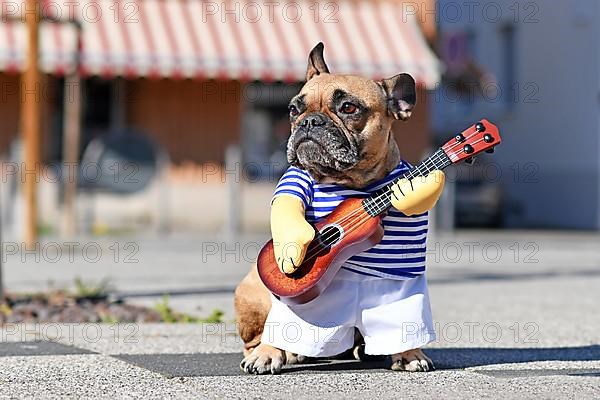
left=381, top=74, right=417, bottom=121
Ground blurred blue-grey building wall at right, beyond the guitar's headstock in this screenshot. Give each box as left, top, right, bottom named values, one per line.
left=432, top=0, right=600, bottom=229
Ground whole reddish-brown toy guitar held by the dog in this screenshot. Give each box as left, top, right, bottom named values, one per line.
left=257, top=119, right=501, bottom=304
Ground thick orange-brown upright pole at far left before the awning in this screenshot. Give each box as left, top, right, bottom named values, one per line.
left=21, top=0, right=41, bottom=249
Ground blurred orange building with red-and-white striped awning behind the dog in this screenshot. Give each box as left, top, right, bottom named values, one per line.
left=0, top=0, right=440, bottom=229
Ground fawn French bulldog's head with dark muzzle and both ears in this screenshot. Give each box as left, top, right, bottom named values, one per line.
left=287, top=43, right=416, bottom=188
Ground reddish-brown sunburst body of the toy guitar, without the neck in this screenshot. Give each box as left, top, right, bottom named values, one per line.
left=257, top=199, right=383, bottom=304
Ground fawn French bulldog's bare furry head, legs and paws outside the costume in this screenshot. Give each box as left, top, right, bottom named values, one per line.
left=235, top=43, right=433, bottom=374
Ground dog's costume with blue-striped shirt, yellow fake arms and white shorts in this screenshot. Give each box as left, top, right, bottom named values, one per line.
left=261, top=161, right=444, bottom=357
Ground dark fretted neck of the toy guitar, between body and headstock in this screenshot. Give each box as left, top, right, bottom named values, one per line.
left=363, top=148, right=453, bottom=217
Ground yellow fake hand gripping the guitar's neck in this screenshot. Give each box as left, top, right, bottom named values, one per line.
left=392, top=170, right=446, bottom=215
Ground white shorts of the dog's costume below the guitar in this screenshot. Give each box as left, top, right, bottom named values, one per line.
left=261, top=269, right=435, bottom=357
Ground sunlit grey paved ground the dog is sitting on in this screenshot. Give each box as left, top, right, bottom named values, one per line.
left=0, top=232, right=600, bottom=398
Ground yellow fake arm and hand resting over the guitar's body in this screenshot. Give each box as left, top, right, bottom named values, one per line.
left=271, top=196, right=315, bottom=274
